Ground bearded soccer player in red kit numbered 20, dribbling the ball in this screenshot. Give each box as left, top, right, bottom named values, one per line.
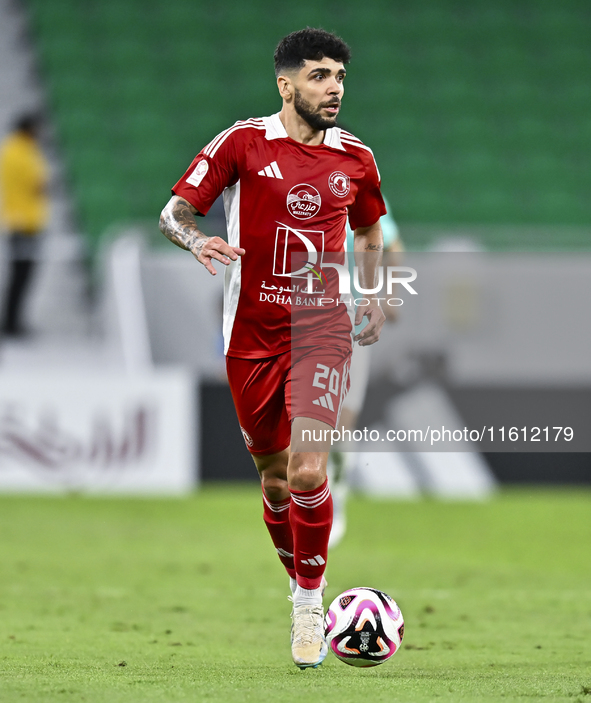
left=160, top=28, right=386, bottom=669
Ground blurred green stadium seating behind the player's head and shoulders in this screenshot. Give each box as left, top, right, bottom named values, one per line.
left=27, top=0, right=591, bottom=248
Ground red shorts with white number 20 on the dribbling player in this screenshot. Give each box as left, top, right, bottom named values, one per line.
left=226, top=345, right=351, bottom=455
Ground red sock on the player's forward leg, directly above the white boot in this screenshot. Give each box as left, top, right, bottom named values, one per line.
left=289, top=480, right=332, bottom=590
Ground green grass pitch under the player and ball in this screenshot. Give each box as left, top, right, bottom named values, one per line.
left=0, top=486, right=591, bottom=703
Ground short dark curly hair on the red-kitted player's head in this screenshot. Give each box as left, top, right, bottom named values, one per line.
left=274, top=27, right=351, bottom=76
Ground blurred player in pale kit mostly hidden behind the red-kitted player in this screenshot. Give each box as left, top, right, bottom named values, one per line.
left=328, top=198, right=402, bottom=548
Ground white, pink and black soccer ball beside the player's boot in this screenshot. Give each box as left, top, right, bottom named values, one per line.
left=324, top=588, right=404, bottom=666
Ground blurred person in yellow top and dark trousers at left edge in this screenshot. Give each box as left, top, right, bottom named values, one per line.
left=0, top=114, right=49, bottom=336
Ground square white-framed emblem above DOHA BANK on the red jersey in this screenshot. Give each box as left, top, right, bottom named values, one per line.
left=273, top=222, right=324, bottom=278
